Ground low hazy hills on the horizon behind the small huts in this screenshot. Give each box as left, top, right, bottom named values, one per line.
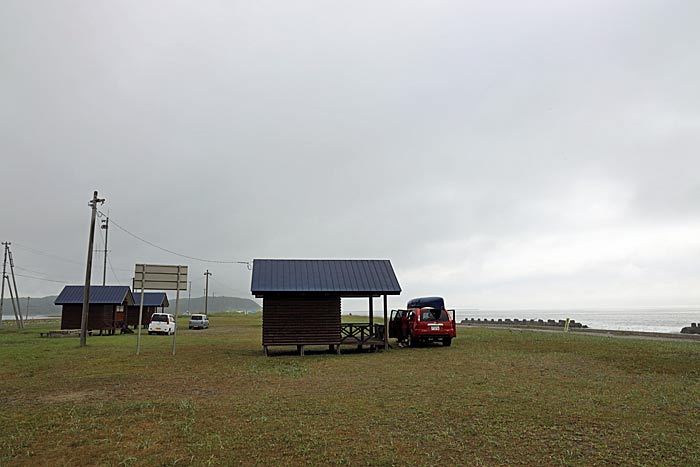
left=2, top=290, right=262, bottom=319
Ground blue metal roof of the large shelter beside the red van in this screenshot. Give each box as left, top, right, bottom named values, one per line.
left=250, top=259, right=401, bottom=296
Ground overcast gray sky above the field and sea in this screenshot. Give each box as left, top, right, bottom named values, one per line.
left=0, top=0, right=700, bottom=308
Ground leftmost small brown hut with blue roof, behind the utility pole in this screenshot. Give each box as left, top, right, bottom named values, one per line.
left=54, top=285, right=134, bottom=334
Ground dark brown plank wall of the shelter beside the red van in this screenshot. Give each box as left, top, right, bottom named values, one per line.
left=263, top=297, right=340, bottom=345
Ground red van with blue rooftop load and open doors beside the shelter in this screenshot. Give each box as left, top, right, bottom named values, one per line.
left=389, top=297, right=457, bottom=347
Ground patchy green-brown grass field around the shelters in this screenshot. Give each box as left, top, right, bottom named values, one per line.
left=0, top=314, right=700, bottom=466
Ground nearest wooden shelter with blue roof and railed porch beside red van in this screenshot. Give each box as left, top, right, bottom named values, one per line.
left=251, top=259, right=401, bottom=355
